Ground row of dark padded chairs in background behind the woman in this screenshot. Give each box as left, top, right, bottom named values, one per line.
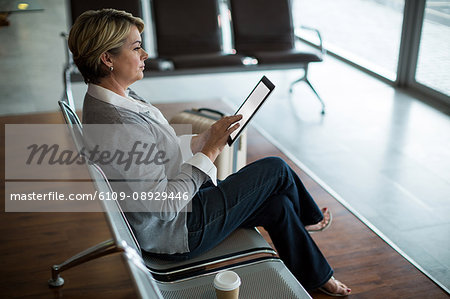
left=64, top=0, right=325, bottom=114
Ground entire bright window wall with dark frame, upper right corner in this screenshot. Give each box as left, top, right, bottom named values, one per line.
left=292, top=0, right=450, bottom=104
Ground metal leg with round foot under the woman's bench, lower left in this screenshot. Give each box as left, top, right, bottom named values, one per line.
left=48, top=239, right=123, bottom=287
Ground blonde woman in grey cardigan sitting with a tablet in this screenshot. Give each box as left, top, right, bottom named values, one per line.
left=69, top=9, right=351, bottom=296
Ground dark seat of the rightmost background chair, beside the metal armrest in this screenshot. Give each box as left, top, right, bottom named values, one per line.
left=251, top=50, right=322, bottom=64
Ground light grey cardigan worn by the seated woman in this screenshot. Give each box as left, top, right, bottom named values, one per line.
left=82, top=91, right=209, bottom=254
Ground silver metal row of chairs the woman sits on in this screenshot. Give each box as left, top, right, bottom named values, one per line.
left=49, top=101, right=310, bottom=298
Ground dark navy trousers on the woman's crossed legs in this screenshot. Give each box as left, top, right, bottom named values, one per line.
left=186, top=157, right=333, bottom=289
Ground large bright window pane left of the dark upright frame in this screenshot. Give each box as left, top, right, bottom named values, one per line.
left=293, top=0, right=405, bottom=81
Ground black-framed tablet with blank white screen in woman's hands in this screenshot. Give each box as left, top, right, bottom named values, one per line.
left=228, top=76, right=275, bottom=146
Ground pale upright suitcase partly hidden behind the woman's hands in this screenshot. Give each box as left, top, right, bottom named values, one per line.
left=170, top=108, right=247, bottom=180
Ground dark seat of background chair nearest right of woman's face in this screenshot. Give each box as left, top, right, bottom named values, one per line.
left=169, top=53, right=248, bottom=70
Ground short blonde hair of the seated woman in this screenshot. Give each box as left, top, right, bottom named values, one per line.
left=68, top=9, right=144, bottom=83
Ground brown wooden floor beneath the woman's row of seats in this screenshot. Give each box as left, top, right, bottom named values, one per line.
left=0, top=104, right=448, bottom=298
